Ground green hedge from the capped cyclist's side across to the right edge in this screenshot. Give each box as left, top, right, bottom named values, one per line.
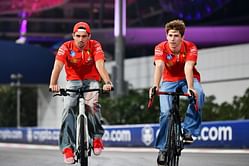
left=101, top=89, right=249, bottom=124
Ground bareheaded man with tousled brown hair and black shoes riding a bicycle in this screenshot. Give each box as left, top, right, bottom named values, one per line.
left=149, top=20, right=204, bottom=165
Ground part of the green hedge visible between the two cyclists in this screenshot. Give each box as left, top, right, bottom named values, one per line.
left=100, top=89, right=159, bottom=124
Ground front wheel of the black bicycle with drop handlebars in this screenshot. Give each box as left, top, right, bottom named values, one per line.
left=166, top=115, right=179, bottom=166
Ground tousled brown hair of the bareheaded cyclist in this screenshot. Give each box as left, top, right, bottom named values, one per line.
left=165, top=20, right=186, bottom=36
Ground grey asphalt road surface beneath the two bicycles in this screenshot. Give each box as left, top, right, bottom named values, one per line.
left=0, top=144, right=249, bottom=166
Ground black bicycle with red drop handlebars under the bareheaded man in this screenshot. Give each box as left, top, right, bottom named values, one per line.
left=148, top=87, right=198, bottom=166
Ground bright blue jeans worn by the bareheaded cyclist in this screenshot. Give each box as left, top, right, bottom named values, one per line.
left=155, top=79, right=205, bottom=151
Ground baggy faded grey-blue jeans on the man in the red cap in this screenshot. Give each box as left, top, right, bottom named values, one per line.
left=59, top=80, right=104, bottom=151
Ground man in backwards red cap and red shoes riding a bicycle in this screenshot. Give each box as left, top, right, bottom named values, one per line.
left=49, top=22, right=113, bottom=164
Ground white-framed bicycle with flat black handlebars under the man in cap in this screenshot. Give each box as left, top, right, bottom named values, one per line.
left=50, top=88, right=113, bottom=166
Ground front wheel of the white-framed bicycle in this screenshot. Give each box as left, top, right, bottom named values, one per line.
left=77, top=116, right=88, bottom=166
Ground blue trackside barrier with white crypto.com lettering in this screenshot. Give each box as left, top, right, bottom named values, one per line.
left=0, top=120, right=249, bottom=148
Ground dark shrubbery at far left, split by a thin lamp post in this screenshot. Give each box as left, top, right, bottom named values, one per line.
left=0, top=86, right=37, bottom=127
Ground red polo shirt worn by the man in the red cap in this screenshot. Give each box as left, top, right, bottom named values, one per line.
left=56, top=40, right=105, bottom=81
